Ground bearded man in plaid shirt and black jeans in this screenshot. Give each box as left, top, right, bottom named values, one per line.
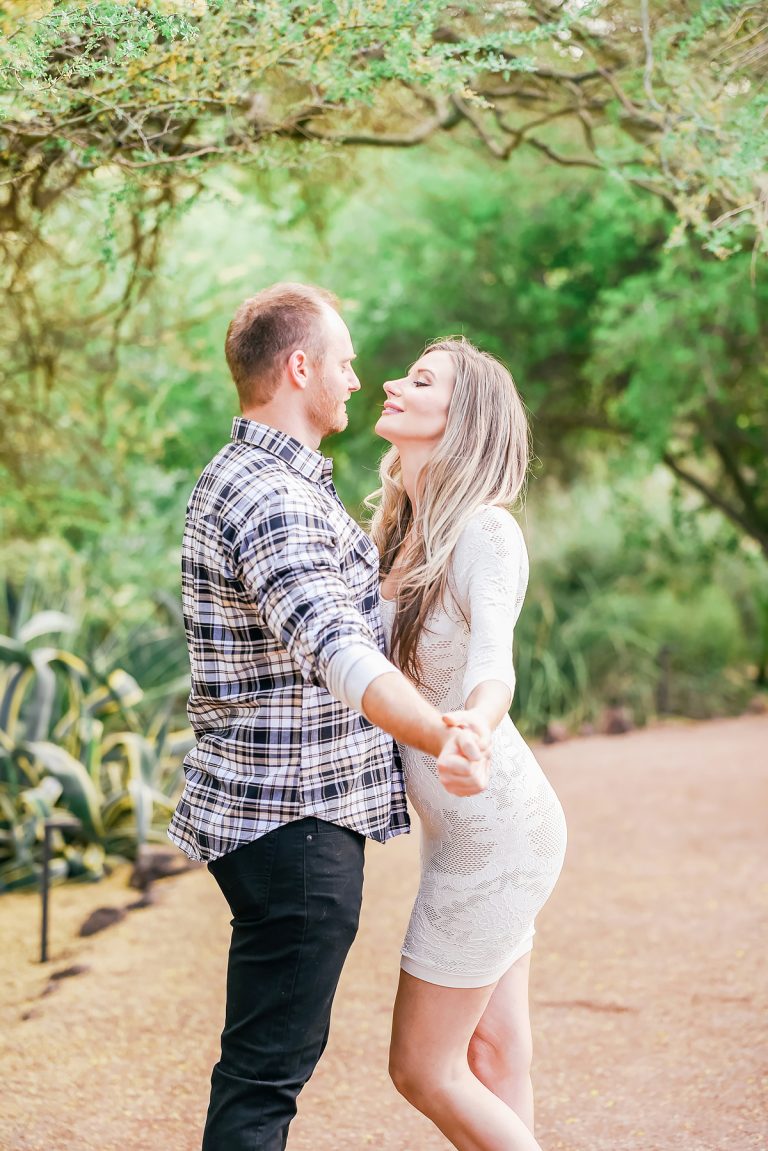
left=169, top=283, right=487, bottom=1151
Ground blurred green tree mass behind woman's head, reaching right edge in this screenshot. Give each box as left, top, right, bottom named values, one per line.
left=313, top=152, right=768, bottom=555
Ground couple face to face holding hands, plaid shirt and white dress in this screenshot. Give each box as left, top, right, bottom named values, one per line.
left=169, top=283, right=565, bottom=1151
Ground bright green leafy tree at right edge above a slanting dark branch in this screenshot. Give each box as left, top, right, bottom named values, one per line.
left=584, top=241, right=768, bottom=555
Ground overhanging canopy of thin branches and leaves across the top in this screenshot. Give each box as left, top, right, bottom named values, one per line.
left=0, top=0, right=768, bottom=251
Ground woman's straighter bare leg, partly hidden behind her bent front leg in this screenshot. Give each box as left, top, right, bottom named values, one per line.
left=469, top=952, right=533, bottom=1131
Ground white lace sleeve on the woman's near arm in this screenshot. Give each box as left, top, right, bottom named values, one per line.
left=454, top=508, right=529, bottom=700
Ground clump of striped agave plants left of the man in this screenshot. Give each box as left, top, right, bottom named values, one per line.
left=0, top=584, right=192, bottom=891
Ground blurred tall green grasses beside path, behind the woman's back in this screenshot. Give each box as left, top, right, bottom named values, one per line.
left=512, top=473, right=768, bottom=733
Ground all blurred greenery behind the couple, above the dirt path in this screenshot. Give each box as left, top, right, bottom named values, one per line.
left=0, top=0, right=768, bottom=890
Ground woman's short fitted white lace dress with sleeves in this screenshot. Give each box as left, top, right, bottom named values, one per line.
left=382, top=508, right=565, bottom=988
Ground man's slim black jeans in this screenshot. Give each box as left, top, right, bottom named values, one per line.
left=203, top=818, right=365, bottom=1151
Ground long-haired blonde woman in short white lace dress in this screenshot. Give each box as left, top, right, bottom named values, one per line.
left=372, top=338, right=565, bottom=1151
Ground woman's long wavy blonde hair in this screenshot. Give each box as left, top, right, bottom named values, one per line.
left=366, top=336, right=530, bottom=684
